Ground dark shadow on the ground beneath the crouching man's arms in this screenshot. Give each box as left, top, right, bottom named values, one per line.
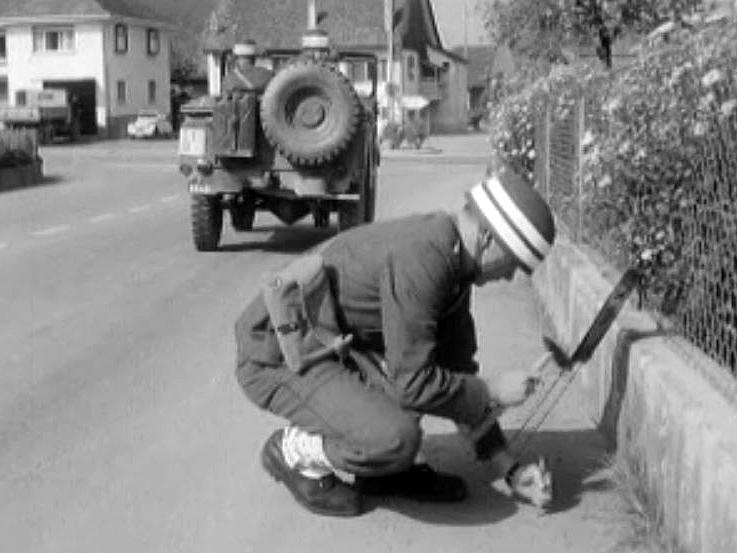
left=374, top=430, right=613, bottom=526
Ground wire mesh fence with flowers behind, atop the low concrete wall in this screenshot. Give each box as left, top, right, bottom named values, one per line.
left=535, top=56, right=737, bottom=376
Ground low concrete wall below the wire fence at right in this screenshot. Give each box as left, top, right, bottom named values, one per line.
left=533, top=238, right=737, bottom=553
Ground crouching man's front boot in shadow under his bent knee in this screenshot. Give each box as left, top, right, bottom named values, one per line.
left=356, top=463, right=468, bottom=503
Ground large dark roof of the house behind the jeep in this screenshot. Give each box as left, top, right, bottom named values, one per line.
left=205, top=0, right=443, bottom=58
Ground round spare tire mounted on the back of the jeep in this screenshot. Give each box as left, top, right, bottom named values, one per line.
left=261, top=60, right=361, bottom=166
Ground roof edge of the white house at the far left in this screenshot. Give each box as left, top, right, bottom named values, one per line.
left=0, top=0, right=166, bottom=21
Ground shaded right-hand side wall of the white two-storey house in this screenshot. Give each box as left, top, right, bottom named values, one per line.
left=104, top=22, right=170, bottom=117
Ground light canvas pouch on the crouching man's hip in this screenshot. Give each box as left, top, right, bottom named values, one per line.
left=262, top=255, right=353, bottom=373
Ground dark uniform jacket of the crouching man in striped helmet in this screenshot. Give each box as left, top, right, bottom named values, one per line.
left=323, top=213, right=488, bottom=425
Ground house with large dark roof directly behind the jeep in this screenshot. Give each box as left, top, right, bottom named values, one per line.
left=205, top=0, right=467, bottom=132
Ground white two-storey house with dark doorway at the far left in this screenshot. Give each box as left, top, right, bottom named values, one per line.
left=0, top=0, right=171, bottom=136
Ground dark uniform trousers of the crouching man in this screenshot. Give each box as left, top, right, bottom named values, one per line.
left=236, top=295, right=422, bottom=476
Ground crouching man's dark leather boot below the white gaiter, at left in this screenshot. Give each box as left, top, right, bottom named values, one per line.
left=261, top=430, right=364, bottom=517
